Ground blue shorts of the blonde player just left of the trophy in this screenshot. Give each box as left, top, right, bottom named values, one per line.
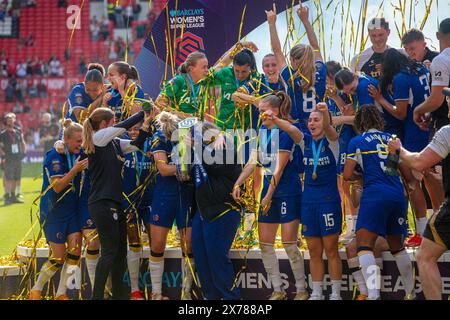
left=150, top=186, right=194, bottom=229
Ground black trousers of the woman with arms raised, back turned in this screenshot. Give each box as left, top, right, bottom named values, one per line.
left=89, top=200, right=130, bottom=300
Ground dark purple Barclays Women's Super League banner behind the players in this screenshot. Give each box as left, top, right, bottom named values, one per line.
left=136, top=0, right=307, bottom=97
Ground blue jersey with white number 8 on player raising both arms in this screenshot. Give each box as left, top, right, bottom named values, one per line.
left=281, top=61, right=327, bottom=132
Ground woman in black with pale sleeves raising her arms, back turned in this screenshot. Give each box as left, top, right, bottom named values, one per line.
left=83, top=108, right=157, bottom=299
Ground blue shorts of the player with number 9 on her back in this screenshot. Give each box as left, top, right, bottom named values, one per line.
left=356, top=197, right=407, bottom=236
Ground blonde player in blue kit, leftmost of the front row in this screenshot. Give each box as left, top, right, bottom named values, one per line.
left=30, top=120, right=88, bottom=300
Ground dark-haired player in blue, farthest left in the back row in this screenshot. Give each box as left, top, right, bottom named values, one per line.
left=64, top=63, right=106, bottom=122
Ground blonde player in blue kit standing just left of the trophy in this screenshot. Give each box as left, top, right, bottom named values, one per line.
left=149, top=111, right=195, bottom=300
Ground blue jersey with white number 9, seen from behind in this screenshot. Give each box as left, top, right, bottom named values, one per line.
left=347, top=130, right=404, bottom=201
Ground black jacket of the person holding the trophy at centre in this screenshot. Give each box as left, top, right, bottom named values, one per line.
left=195, top=143, right=242, bottom=220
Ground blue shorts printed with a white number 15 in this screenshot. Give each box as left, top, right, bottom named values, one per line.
left=301, top=201, right=342, bottom=237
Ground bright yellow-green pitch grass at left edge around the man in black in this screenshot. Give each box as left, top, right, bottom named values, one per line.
left=0, top=163, right=42, bottom=256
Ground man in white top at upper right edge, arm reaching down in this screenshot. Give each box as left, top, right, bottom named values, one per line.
left=413, top=18, right=450, bottom=131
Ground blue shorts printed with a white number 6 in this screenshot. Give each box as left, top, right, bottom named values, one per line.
left=258, top=195, right=301, bottom=223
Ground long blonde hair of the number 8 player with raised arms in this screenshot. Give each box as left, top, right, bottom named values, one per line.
left=289, top=44, right=316, bottom=92
